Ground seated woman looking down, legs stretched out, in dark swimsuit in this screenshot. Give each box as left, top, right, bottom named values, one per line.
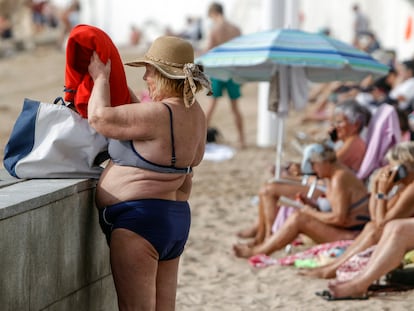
left=233, top=144, right=369, bottom=258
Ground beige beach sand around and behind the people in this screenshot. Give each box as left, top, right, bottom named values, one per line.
left=0, top=47, right=414, bottom=311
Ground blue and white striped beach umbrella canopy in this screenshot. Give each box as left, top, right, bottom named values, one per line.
left=196, top=29, right=389, bottom=82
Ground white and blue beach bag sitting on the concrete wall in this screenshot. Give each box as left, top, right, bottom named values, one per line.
left=3, top=97, right=108, bottom=178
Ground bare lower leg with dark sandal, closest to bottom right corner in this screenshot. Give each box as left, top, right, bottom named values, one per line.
left=329, top=219, right=414, bottom=297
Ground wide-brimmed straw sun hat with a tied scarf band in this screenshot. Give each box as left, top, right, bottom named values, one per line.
left=125, top=36, right=211, bottom=107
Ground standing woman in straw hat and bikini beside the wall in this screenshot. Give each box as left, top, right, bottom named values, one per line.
left=88, top=36, right=210, bottom=310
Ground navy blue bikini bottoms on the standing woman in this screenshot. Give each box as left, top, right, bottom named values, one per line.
left=99, top=199, right=191, bottom=260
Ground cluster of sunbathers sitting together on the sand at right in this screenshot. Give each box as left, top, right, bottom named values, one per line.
left=233, top=50, right=414, bottom=300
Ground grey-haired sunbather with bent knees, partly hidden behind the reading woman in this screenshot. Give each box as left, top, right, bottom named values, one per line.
left=238, top=100, right=370, bottom=243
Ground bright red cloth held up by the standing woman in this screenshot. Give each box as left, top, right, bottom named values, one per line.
left=65, top=25, right=131, bottom=118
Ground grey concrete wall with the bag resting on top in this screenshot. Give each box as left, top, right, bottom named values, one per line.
left=0, top=170, right=117, bottom=311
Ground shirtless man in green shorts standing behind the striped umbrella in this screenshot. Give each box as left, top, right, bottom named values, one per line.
left=206, top=2, right=246, bottom=148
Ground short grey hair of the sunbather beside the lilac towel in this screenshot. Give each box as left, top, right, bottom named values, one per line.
left=334, top=99, right=371, bottom=132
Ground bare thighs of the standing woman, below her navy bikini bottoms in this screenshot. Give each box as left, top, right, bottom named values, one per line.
left=110, top=229, right=178, bottom=311
